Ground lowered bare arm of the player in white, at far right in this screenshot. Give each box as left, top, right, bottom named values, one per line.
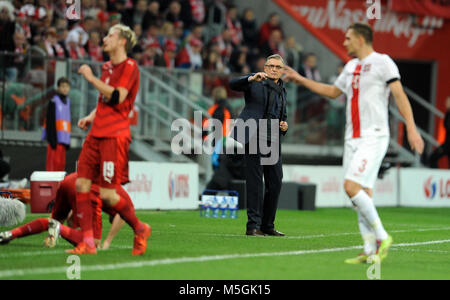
left=389, top=80, right=424, bottom=154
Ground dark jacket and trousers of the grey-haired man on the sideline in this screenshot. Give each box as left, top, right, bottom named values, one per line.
left=230, top=75, right=287, bottom=231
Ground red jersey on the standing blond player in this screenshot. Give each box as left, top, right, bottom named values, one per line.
left=90, top=58, right=139, bottom=139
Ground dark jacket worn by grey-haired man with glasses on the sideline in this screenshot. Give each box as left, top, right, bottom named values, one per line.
left=230, top=74, right=287, bottom=144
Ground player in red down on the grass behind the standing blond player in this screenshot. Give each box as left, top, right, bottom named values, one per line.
left=0, top=173, right=128, bottom=250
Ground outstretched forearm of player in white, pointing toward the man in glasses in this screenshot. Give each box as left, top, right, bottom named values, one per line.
left=284, top=66, right=342, bottom=99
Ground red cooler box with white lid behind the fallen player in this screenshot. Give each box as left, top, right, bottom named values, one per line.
left=30, top=171, right=66, bottom=213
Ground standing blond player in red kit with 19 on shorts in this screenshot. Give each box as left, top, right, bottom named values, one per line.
left=70, top=24, right=151, bottom=255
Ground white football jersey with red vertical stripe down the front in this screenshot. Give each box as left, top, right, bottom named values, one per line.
left=334, top=52, right=400, bottom=140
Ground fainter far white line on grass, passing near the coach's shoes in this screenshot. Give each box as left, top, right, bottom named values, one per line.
left=0, top=227, right=450, bottom=258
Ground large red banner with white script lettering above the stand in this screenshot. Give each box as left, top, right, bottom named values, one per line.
left=274, top=0, right=450, bottom=141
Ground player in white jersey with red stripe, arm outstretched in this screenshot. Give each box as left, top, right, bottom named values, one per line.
left=284, top=23, right=424, bottom=264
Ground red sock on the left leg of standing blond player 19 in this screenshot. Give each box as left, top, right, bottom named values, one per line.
left=77, top=193, right=95, bottom=248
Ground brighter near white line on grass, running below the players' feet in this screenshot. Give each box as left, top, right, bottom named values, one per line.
left=0, top=240, right=450, bottom=278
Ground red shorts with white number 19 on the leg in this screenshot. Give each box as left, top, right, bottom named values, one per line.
left=77, top=135, right=130, bottom=189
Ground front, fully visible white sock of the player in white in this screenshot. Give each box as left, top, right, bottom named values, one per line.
left=350, top=190, right=388, bottom=241
